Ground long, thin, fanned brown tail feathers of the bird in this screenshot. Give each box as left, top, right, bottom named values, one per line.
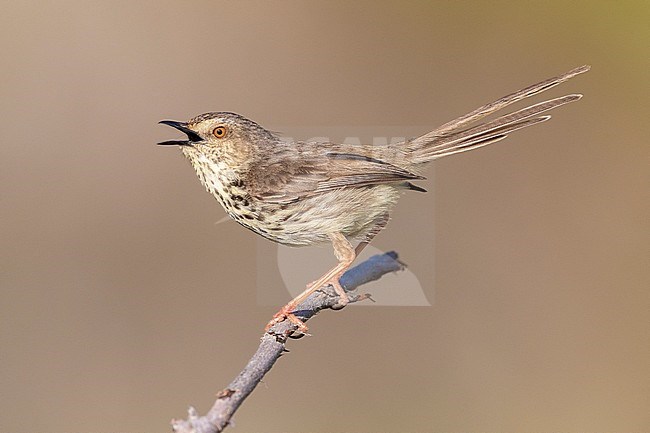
left=404, top=65, right=590, bottom=164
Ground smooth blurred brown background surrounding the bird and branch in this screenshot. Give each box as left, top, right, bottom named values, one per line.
left=0, top=1, right=650, bottom=433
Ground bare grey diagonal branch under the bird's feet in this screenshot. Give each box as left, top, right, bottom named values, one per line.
left=172, top=252, right=405, bottom=433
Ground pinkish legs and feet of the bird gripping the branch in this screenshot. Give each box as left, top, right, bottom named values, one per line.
left=265, top=233, right=356, bottom=333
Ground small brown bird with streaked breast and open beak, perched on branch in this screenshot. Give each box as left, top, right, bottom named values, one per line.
left=159, top=66, right=589, bottom=332
